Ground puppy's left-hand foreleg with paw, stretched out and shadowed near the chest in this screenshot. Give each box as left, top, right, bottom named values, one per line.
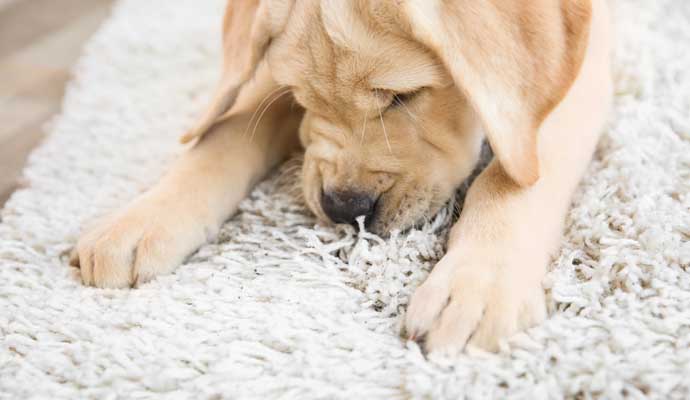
left=72, top=76, right=301, bottom=288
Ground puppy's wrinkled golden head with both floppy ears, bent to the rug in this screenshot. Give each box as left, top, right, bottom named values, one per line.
left=180, top=0, right=591, bottom=233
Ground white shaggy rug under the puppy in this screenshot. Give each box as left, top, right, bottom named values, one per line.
left=0, top=0, right=690, bottom=400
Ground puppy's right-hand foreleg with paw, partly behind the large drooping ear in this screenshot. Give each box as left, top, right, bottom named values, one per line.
left=406, top=2, right=611, bottom=354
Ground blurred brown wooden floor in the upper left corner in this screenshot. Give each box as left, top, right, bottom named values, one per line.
left=0, top=0, right=113, bottom=208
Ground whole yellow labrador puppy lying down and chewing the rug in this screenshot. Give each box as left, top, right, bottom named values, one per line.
left=74, top=0, right=611, bottom=353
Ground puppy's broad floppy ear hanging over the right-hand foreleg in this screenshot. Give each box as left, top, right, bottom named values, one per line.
left=404, top=0, right=592, bottom=186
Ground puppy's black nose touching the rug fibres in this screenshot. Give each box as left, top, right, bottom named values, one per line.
left=321, top=191, right=376, bottom=225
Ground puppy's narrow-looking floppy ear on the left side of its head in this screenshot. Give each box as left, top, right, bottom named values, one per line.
left=180, top=0, right=294, bottom=143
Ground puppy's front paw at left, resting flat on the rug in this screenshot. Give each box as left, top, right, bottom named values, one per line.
left=71, top=199, right=211, bottom=288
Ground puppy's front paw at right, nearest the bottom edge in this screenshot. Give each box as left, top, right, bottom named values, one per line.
left=405, top=254, right=546, bottom=355
